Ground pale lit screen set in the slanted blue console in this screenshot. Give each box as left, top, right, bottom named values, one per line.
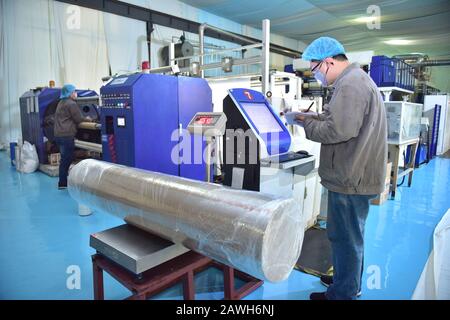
left=241, top=102, right=283, bottom=133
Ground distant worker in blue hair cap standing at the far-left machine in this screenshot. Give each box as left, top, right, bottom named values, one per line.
left=54, top=84, right=92, bottom=189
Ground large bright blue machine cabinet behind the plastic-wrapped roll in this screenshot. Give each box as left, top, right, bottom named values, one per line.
left=100, top=73, right=212, bottom=180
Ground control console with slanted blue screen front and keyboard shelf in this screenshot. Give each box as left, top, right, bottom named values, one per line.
left=223, top=89, right=315, bottom=203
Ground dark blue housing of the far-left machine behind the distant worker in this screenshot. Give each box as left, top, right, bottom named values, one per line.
left=19, top=88, right=98, bottom=164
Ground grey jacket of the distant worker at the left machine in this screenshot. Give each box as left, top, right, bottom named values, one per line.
left=54, top=98, right=84, bottom=137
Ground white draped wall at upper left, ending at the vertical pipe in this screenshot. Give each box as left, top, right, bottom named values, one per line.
left=0, top=0, right=148, bottom=143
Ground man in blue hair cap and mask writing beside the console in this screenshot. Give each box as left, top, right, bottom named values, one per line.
left=296, top=37, right=387, bottom=300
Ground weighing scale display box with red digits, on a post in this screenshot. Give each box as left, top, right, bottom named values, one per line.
left=187, top=112, right=227, bottom=137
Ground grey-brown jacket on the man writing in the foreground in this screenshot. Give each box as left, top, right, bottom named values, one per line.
left=304, top=63, right=387, bottom=195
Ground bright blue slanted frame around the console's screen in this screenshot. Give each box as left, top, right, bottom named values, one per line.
left=229, top=88, right=291, bottom=156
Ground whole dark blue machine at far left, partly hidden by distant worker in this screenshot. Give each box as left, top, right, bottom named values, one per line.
left=19, top=87, right=101, bottom=164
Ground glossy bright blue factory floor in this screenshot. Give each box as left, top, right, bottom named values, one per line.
left=0, top=152, right=450, bottom=299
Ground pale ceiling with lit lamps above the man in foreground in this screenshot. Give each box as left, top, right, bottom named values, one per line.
left=181, top=0, right=450, bottom=58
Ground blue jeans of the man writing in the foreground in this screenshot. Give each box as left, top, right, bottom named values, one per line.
left=327, top=191, right=375, bottom=300
